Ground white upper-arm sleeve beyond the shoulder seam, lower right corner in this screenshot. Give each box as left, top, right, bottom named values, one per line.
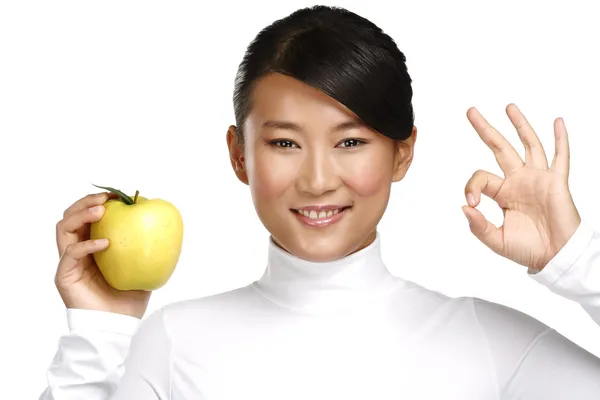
left=473, top=298, right=600, bottom=400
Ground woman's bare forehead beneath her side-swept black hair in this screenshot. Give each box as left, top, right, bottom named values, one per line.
left=248, top=73, right=357, bottom=126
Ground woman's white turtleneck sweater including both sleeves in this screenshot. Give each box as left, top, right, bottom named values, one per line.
left=40, top=222, right=600, bottom=400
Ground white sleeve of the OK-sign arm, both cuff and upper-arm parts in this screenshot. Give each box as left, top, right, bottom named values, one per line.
left=474, top=222, right=600, bottom=400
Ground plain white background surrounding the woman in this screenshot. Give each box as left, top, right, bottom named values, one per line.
left=0, top=0, right=600, bottom=399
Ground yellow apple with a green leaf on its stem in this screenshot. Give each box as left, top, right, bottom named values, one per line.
left=90, top=185, right=183, bottom=290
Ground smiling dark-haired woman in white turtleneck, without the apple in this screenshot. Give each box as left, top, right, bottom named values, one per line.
left=40, top=3, right=600, bottom=400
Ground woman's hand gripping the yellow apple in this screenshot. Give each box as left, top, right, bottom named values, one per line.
left=54, top=192, right=152, bottom=319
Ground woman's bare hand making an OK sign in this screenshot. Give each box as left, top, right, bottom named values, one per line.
left=463, top=104, right=581, bottom=273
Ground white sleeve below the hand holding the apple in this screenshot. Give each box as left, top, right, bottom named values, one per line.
left=39, top=309, right=170, bottom=400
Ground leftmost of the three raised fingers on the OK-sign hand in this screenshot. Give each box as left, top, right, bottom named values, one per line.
left=467, top=107, right=523, bottom=175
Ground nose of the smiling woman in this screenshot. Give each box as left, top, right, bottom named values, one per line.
left=296, top=148, right=341, bottom=196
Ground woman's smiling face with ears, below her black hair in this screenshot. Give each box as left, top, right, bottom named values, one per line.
left=227, top=74, right=416, bottom=261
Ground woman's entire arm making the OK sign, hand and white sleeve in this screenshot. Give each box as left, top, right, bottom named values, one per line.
left=463, top=104, right=600, bottom=400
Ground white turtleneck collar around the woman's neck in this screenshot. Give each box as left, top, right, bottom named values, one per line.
left=252, top=233, right=403, bottom=314
